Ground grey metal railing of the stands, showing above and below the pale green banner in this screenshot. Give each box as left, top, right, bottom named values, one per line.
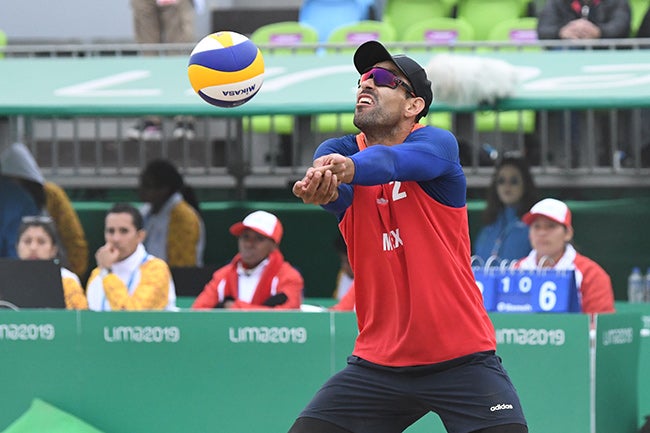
left=0, top=39, right=650, bottom=197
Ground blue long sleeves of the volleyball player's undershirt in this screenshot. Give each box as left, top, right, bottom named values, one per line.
left=314, top=127, right=467, bottom=217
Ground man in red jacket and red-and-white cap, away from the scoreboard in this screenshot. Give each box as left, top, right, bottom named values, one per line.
left=192, top=210, right=304, bottom=310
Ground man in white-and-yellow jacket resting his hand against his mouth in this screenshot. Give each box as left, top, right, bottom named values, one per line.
left=86, top=203, right=176, bottom=311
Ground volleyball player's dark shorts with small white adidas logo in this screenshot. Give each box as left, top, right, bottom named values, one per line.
left=300, top=352, right=526, bottom=433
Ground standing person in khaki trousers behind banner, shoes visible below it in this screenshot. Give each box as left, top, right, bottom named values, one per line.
left=126, top=0, right=196, bottom=141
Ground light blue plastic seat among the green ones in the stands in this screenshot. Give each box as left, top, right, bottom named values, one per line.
left=298, top=0, right=370, bottom=43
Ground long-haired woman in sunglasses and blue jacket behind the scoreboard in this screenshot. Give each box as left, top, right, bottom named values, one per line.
left=474, top=157, right=537, bottom=262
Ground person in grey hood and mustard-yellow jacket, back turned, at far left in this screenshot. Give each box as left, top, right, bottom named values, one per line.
left=0, top=143, right=88, bottom=277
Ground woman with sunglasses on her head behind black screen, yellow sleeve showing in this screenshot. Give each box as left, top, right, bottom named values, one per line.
left=16, top=215, right=88, bottom=310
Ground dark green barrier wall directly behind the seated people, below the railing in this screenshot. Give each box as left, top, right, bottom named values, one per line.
left=73, top=198, right=650, bottom=300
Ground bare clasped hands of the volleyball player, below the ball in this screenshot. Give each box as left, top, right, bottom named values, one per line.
left=292, top=153, right=354, bottom=205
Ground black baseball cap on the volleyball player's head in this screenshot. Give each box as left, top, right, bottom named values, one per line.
left=354, top=40, right=433, bottom=117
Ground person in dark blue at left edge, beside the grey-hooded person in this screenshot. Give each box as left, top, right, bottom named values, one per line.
left=0, top=175, right=38, bottom=258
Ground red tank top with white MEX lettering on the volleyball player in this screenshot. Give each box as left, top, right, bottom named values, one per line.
left=339, top=134, right=496, bottom=367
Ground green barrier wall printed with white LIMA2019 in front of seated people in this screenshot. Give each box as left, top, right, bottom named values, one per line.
left=0, top=310, right=640, bottom=433
